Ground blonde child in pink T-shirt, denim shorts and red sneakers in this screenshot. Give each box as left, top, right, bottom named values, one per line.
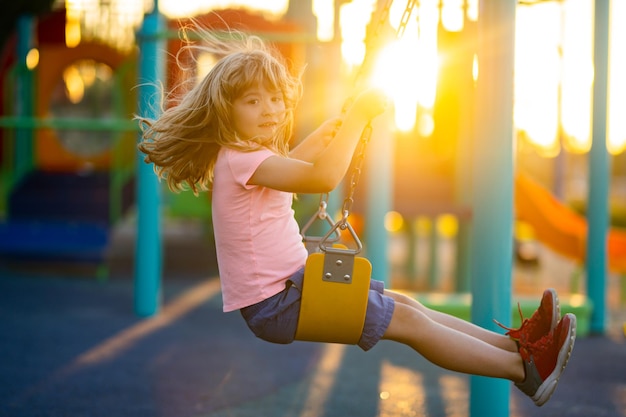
left=138, top=26, right=576, bottom=406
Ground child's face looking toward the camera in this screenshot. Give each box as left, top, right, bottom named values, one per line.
left=232, top=85, right=285, bottom=140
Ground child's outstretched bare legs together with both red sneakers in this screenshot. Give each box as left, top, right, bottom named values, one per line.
left=372, top=290, right=576, bottom=406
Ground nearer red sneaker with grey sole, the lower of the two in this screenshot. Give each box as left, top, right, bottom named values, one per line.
left=515, top=313, right=576, bottom=406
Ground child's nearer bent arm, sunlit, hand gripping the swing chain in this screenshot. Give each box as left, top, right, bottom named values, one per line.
left=248, top=90, right=387, bottom=193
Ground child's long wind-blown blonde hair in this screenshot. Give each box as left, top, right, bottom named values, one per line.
left=135, top=26, right=302, bottom=195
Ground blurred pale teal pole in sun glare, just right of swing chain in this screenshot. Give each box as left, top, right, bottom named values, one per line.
left=364, top=115, right=394, bottom=288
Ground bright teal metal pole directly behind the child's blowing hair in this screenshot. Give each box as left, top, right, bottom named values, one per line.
left=135, top=1, right=164, bottom=316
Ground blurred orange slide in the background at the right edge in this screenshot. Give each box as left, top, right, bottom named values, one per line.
left=515, top=173, right=626, bottom=273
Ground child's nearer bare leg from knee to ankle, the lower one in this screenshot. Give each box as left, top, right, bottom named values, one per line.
left=383, top=296, right=525, bottom=382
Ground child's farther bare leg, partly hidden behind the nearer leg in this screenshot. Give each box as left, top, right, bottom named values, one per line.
left=385, top=290, right=518, bottom=352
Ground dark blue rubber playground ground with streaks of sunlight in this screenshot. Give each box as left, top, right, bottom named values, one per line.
left=0, top=268, right=626, bottom=417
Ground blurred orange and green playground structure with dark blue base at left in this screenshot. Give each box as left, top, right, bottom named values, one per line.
left=0, top=10, right=303, bottom=272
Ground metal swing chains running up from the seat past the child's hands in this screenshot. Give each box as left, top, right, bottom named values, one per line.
left=339, top=0, right=418, bottom=230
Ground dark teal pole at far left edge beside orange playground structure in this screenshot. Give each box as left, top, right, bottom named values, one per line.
left=13, top=15, right=35, bottom=180
